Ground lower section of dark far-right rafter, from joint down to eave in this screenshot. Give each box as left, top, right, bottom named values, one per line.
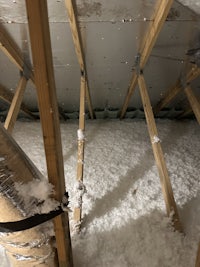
left=153, top=80, right=182, bottom=115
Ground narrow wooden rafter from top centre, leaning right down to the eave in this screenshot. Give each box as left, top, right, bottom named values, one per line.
left=65, top=0, right=95, bottom=119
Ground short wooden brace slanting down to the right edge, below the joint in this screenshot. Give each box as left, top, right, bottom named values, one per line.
left=184, top=85, right=200, bottom=124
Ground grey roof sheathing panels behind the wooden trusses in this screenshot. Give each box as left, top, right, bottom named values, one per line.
left=0, top=0, right=200, bottom=119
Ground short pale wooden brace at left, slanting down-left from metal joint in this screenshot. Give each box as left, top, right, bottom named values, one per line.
left=4, top=76, right=27, bottom=134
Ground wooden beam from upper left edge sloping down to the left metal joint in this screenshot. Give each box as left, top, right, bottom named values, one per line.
left=0, top=25, right=34, bottom=83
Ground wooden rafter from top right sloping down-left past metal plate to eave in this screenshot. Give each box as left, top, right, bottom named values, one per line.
left=120, top=0, right=173, bottom=119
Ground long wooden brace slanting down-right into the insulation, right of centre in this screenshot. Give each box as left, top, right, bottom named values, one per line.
left=138, top=75, right=182, bottom=231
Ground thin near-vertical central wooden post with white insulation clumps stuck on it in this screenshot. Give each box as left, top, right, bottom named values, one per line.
left=74, top=76, right=86, bottom=232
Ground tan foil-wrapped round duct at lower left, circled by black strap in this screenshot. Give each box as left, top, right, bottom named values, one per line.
left=0, top=125, right=57, bottom=267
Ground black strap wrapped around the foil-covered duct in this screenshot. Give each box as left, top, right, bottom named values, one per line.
left=0, top=192, right=70, bottom=233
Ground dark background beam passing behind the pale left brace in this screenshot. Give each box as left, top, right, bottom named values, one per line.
left=0, top=84, right=37, bottom=119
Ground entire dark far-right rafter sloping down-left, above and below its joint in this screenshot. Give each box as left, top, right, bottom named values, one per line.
left=154, top=65, right=200, bottom=114
